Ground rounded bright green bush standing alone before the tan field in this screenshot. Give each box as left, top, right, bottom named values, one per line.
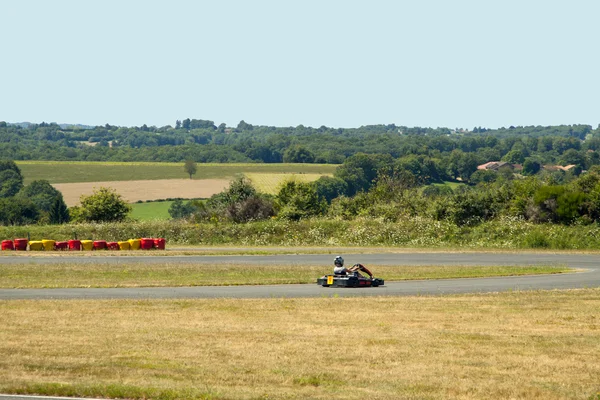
left=78, top=187, right=131, bottom=222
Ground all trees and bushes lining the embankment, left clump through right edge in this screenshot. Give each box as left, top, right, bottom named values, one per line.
left=0, top=150, right=600, bottom=233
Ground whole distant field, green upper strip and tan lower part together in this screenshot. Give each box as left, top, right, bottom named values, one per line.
left=17, top=161, right=337, bottom=206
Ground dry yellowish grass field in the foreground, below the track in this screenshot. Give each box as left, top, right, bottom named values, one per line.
left=0, top=289, right=600, bottom=400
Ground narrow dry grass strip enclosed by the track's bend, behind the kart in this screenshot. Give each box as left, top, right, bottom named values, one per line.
left=0, top=262, right=571, bottom=288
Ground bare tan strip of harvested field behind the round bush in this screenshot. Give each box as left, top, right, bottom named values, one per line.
left=52, top=179, right=229, bottom=207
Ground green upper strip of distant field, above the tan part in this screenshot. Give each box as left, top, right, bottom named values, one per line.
left=17, top=161, right=337, bottom=184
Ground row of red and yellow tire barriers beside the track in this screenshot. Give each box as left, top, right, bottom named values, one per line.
left=1, top=238, right=166, bottom=251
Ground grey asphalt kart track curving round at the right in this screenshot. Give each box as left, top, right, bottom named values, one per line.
left=0, top=253, right=600, bottom=300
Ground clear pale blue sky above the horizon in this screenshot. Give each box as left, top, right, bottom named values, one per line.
left=0, top=0, right=600, bottom=129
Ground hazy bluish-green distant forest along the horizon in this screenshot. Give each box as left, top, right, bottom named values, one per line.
left=0, top=119, right=600, bottom=170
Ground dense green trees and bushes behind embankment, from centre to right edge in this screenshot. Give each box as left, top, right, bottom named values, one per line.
left=169, top=154, right=600, bottom=226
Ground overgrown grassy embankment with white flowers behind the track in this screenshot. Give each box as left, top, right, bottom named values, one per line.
left=0, top=217, right=600, bottom=250
